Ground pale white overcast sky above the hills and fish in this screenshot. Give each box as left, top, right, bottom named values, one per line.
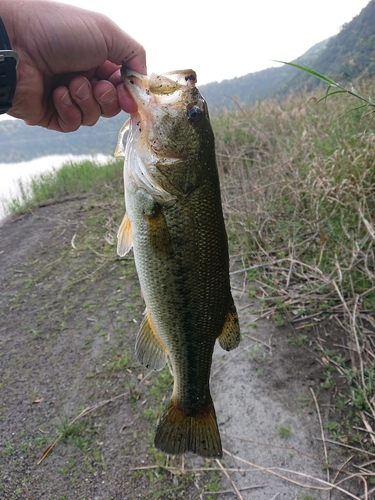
left=61, top=0, right=369, bottom=84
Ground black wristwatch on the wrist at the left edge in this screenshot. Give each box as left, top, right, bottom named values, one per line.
left=0, top=17, right=18, bottom=115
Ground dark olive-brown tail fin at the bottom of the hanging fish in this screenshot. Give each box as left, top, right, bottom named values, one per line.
left=155, top=397, right=223, bottom=458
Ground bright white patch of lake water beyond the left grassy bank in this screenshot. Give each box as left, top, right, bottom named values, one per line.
left=0, top=155, right=113, bottom=220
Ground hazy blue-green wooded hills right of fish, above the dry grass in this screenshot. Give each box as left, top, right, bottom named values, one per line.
left=201, top=0, right=375, bottom=112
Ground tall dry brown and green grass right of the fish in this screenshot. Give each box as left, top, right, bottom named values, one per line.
left=214, top=82, right=375, bottom=490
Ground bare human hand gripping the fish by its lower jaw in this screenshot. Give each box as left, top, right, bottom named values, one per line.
left=0, top=0, right=146, bottom=132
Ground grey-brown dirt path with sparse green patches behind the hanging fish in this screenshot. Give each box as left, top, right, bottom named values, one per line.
left=0, top=197, right=356, bottom=500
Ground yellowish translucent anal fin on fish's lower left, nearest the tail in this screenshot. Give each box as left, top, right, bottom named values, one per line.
left=135, top=311, right=167, bottom=370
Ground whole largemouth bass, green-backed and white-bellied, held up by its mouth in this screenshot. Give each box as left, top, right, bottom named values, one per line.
left=116, top=69, right=240, bottom=457
